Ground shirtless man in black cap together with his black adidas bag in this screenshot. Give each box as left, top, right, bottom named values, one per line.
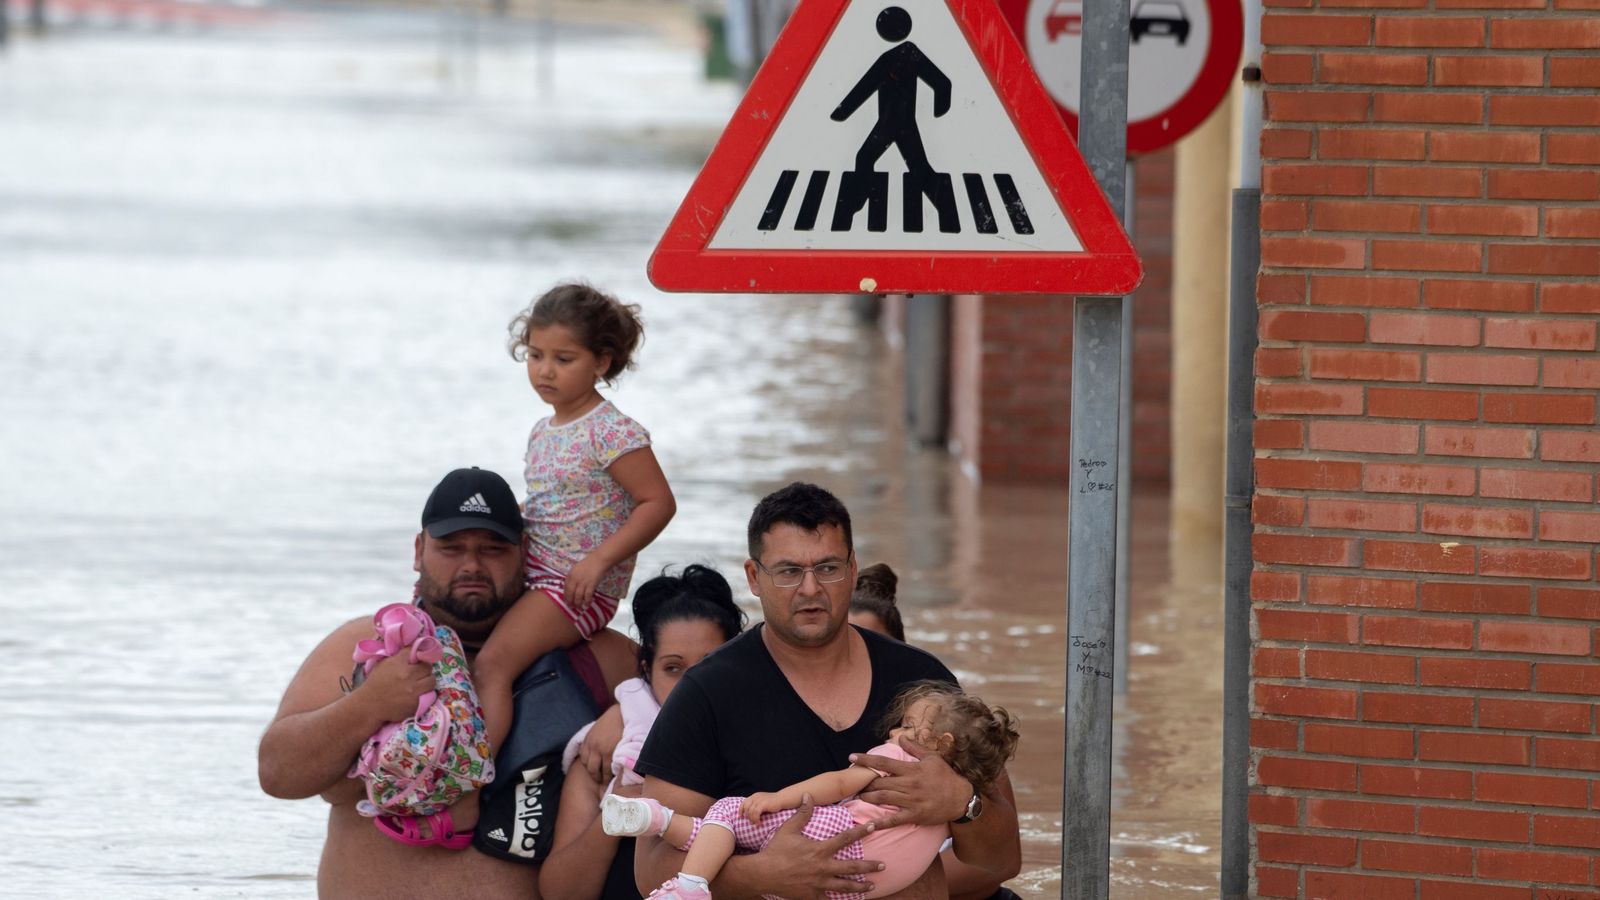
left=259, top=468, right=637, bottom=900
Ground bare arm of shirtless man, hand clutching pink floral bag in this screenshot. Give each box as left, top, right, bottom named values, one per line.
left=256, top=618, right=434, bottom=799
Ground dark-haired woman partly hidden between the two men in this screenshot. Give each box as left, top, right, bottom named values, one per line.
left=539, top=565, right=746, bottom=900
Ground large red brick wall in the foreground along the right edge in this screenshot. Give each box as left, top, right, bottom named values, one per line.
left=1250, top=0, right=1600, bottom=900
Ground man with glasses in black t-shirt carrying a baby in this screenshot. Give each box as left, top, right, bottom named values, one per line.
left=634, top=482, right=1021, bottom=900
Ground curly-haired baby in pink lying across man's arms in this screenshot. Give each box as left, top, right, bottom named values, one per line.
left=600, top=681, right=1018, bottom=900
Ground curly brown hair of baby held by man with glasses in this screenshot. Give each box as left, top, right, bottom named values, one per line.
left=883, top=681, right=1021, bottom=793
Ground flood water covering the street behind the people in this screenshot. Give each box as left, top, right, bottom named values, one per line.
left=0, top=6, right=1221, bottom=898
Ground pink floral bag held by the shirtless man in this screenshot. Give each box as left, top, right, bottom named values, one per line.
left=349, top=604, right=494, bottom=815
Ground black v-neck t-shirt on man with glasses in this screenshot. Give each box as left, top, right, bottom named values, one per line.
left=634, top=626, right=955, bottom=798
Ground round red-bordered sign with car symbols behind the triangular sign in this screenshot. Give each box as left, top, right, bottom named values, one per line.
left=998, top=0, right=1245, bottom=155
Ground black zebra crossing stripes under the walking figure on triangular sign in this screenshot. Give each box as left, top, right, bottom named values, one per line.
left=755, top=168, right=1034, bottom=234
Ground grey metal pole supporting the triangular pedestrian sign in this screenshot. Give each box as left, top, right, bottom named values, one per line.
left=1061, top=0, right=1128, bottom=900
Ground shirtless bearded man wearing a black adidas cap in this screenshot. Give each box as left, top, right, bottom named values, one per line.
left=259, top=469, right=637, bottom=900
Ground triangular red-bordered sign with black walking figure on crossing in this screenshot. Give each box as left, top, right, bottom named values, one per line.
left=650, top=0, right=1142, bottom=295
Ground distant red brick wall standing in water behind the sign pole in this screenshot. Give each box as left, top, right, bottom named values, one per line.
left=950, top=151, right=1173, bottom=485
